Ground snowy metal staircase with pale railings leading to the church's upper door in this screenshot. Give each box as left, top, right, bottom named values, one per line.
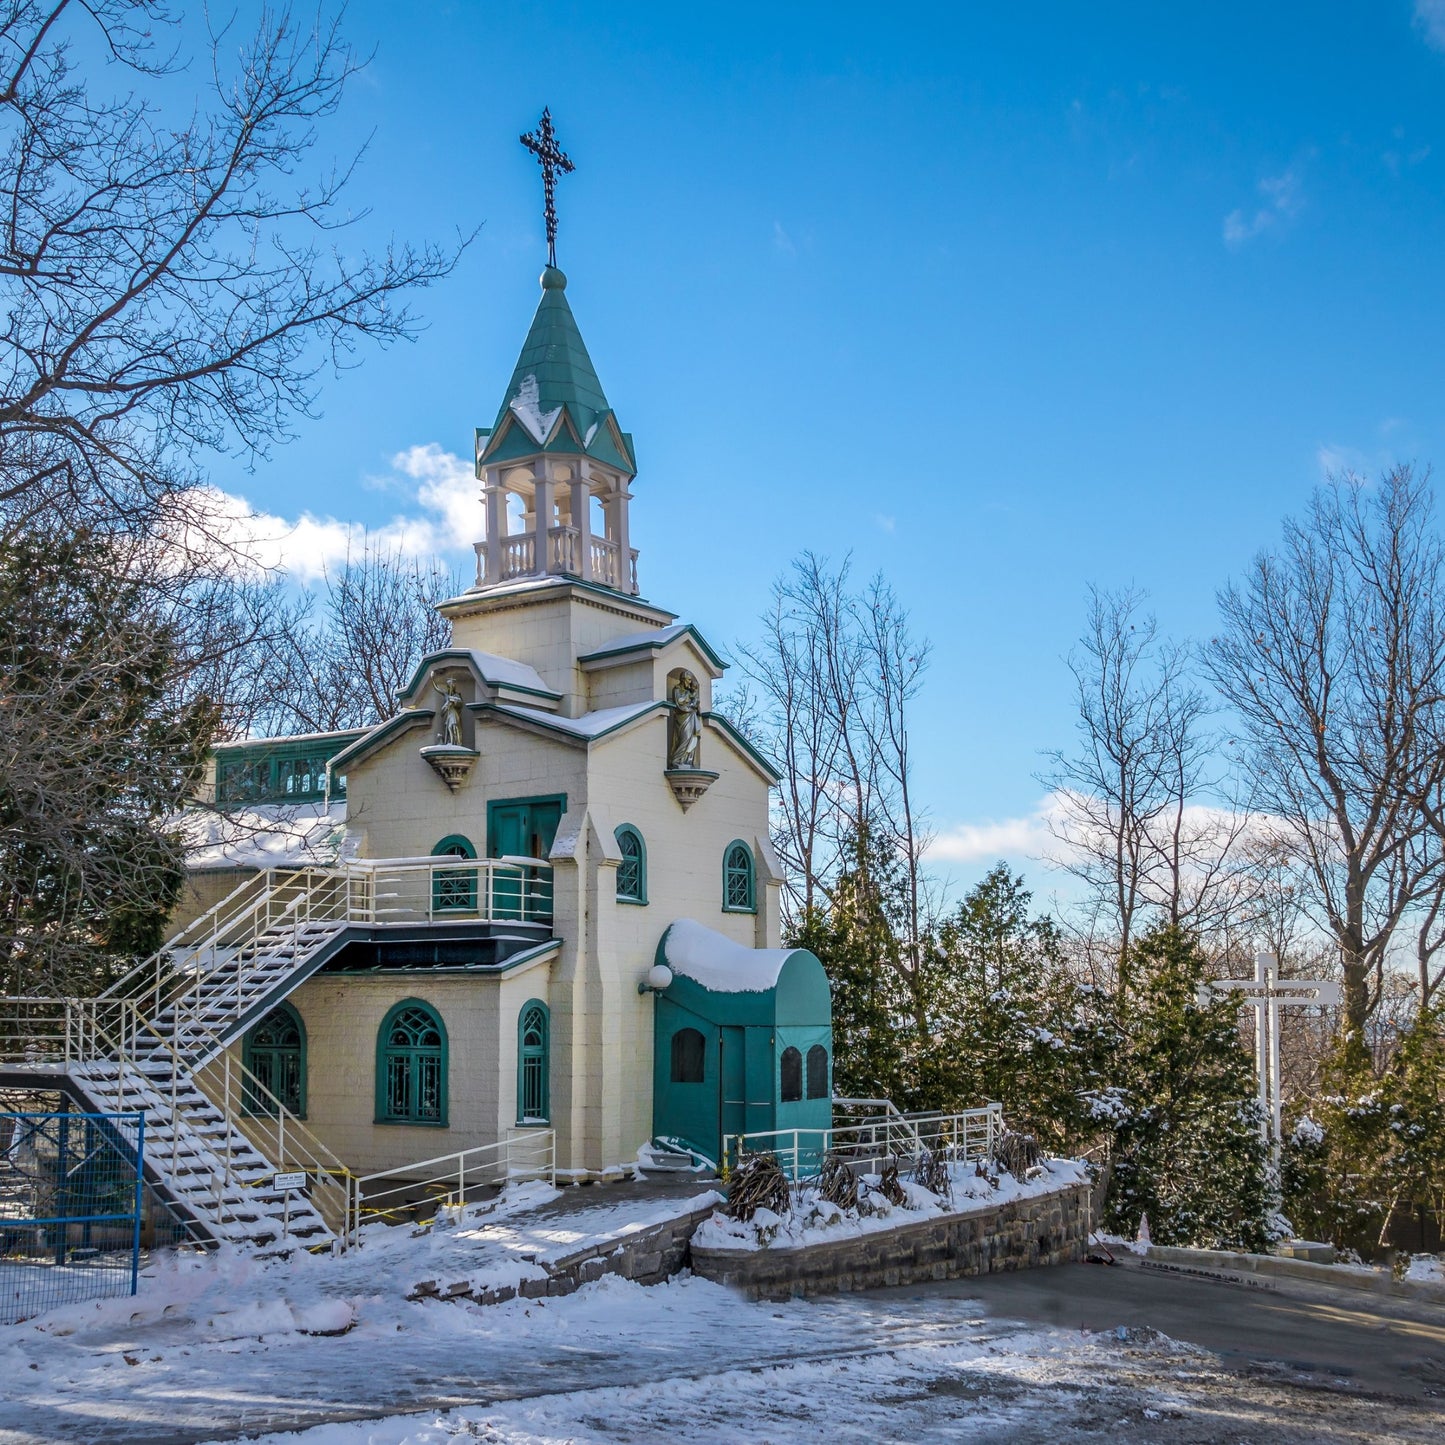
left=0, top=858, right=551, bottom=1248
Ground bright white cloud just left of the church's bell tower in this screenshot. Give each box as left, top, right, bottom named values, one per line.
left=186, top=442, right=483, bottom=584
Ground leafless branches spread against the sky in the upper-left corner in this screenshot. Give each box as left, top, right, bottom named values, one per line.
left=0, top=0, right=458, bottom=543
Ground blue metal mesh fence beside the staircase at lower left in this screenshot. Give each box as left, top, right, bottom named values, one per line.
left=0, top=1113, right=146, bottom=1324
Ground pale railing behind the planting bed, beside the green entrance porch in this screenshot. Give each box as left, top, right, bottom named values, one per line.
left=723, top=1100, right=1003, bottom=1182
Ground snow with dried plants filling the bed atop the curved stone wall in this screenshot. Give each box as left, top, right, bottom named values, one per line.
left=692, top=1159, right=1088, bottom=1250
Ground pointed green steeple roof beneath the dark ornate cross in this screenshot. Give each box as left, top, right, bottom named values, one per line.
left=477, top=266, right=637, bottom=475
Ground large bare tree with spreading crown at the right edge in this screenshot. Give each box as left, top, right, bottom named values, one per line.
left=1205, top=467, right=1445, bottom=1048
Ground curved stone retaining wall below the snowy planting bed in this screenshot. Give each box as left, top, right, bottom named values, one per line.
left=692, top=1185, right=1091, bottom=1299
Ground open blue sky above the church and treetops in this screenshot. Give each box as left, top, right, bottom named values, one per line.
left=215, top=0, right=1445, bottom=890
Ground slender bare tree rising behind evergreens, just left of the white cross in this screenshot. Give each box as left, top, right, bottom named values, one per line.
left=1040, top=588, right=1246, bottom=988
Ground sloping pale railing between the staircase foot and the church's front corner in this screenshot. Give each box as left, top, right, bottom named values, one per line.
left=351, top=1129, right=556, bottom=1227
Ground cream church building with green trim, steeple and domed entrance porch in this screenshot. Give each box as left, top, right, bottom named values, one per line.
left=179, top=264, right=832, bottom=1178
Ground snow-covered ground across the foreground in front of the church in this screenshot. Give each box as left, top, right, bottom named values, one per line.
left=0, top=1186, right=1431, bottom=1445
